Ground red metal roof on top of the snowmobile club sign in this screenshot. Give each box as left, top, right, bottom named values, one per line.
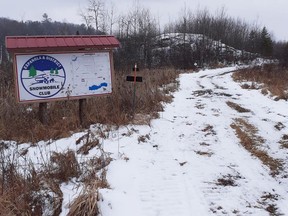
left=6, top=35, right=120, bottom=52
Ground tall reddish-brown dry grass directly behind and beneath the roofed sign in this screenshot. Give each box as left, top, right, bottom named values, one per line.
left=0, top=69, right=179, bottom=143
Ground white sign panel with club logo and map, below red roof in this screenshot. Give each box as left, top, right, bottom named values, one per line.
left=16, top=52, right=112, bottom=102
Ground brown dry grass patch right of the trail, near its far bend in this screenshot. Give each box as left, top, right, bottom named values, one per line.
left=232, top=65, right=288, bottom=100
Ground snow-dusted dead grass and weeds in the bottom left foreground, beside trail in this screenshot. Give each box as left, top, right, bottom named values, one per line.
left=0, top=132, right=111, bottom=216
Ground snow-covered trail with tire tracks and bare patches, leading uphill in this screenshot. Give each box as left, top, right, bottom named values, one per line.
left=99, top=68, right=288, bottom=216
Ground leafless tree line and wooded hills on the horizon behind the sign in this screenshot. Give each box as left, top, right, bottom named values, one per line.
left=0, top=0, right=288, bottom=70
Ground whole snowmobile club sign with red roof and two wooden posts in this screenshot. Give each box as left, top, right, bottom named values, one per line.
left=6, top=35, right=120, bottom=125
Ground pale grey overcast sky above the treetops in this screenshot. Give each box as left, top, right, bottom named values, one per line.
left=0, top=0, right=288, bottom=41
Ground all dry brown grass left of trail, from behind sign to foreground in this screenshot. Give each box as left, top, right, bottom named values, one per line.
left=0, top=69, right=179, bottom=216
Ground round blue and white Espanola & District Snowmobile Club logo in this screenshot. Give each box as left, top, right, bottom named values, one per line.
left=20, top=55, right=66, bottom=98
